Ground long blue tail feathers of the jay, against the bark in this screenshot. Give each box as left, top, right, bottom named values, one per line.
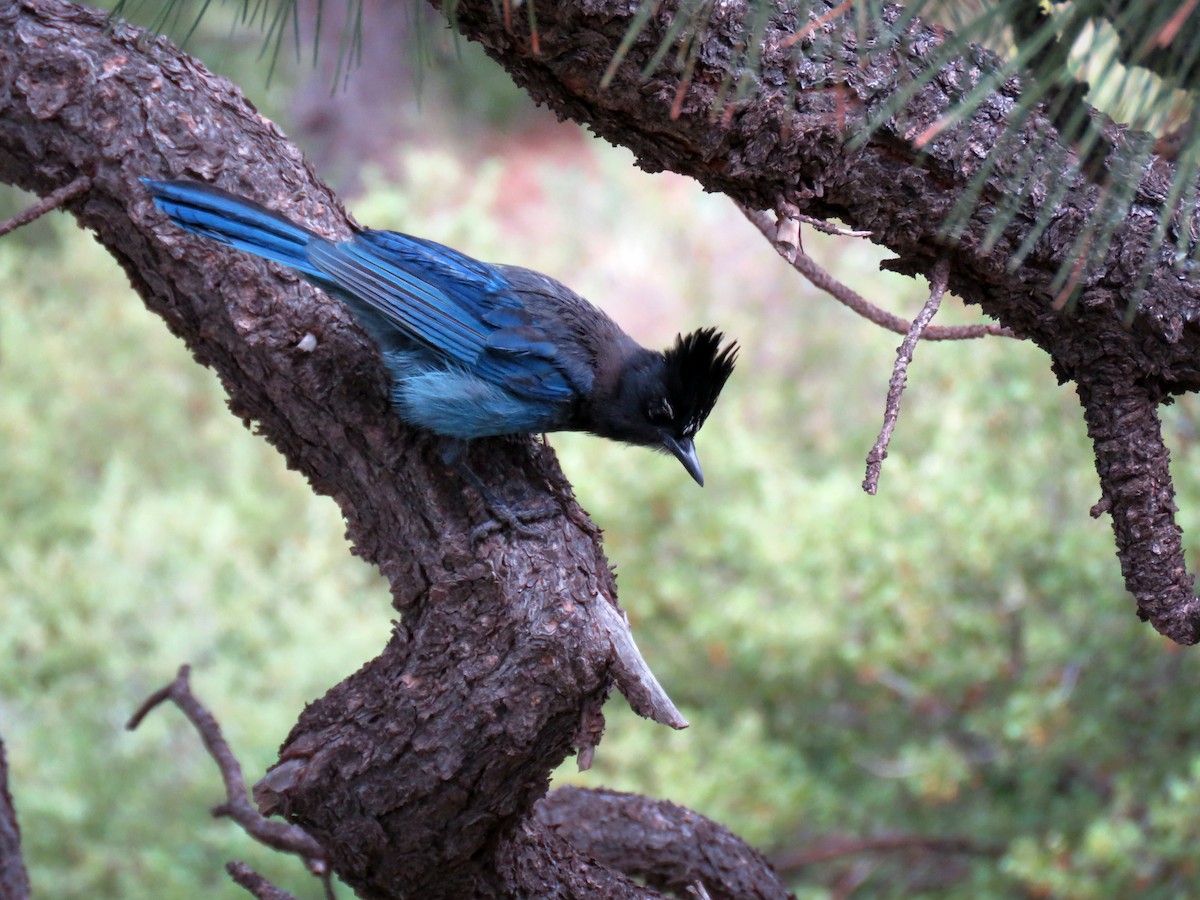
left=142, top=178, right=320, bottom=277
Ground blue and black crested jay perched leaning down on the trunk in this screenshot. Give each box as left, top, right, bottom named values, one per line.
left=143, top=179, right=737, bottom=524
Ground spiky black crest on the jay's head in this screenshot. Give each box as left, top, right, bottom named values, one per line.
left=652, top=328, right=738, bottom=438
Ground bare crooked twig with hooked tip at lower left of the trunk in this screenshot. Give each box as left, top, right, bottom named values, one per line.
left=126, top=665, right=332, bottom=896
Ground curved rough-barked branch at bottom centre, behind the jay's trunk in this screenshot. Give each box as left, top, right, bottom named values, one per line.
left=534, top=787, right=791, bottom=900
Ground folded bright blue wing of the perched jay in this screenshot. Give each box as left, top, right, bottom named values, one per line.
left=308, top=230, right=578, bottom=402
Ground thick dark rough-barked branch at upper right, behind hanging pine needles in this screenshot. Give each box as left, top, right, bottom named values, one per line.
left=434, top=0, right=1200, bottom=642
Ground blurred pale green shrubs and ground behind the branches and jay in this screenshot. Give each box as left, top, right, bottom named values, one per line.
left=7, top=3, right=1200, bottom=898
